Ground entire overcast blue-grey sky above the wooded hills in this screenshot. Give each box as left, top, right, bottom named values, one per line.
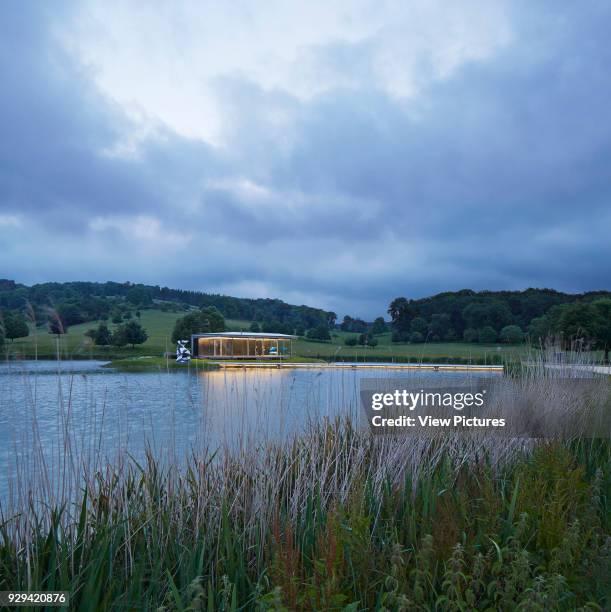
left=0, top=0, right=611, bottom=318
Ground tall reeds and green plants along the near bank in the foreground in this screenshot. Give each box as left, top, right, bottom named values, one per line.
left=0, top=424, right=611, bottom=611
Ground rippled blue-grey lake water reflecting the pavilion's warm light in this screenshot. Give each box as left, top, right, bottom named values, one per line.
left=0, top=361, right=498, bottom=499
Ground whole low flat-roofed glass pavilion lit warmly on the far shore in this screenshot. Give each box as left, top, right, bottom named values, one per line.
left=191, top=332, right=296, bottom=359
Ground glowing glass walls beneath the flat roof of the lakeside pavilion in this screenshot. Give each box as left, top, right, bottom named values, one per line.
left=194, top=337, right=291, bottom=359
